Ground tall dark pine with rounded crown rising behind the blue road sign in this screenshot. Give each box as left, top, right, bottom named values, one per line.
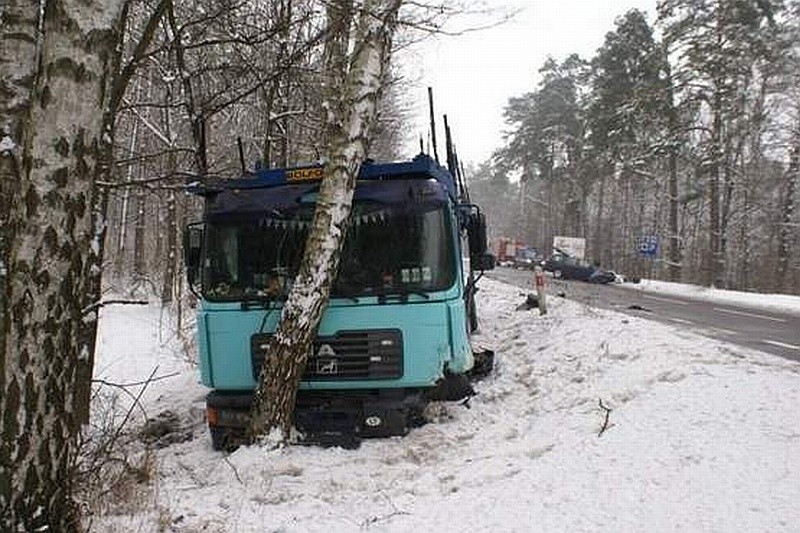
left=586, top=10, right=679, bottom=274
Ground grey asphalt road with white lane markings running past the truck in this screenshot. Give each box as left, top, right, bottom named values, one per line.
left=486, top=267, right=800, bottom=361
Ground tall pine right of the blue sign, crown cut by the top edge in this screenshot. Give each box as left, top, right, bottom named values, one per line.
left=658, top=0, right=781, bottom=286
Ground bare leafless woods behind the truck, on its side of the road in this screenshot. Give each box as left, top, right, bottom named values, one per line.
left=105, top=0, right=410, bottom=312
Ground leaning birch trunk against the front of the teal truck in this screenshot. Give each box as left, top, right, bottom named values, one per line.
left=251, top=0, right=402, bottom=439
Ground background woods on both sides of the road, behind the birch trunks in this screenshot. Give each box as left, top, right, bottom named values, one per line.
left=105, top=0, right=800, bottom=308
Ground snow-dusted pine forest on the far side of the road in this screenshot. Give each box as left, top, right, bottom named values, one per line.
left=471, top=0, right=800, bottom=294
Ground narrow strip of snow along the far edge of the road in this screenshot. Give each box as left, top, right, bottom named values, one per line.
left=618, top=279, right=800, bottom=315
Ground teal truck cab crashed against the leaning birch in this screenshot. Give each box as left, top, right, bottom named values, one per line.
left=185, top=154, right=494, bottom=449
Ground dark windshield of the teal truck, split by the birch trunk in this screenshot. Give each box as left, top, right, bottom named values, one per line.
left=203, top=202, right=456, bottom=300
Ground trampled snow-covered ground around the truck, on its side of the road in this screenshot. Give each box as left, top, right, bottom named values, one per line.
left=92, top=279, right=800, bottom=533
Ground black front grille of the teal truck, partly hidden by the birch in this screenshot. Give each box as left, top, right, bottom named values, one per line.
left=250, top=329, right=403, bottom=381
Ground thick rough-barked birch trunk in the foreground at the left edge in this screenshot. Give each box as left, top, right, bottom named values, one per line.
left=0, top=0, right=122, bottom=531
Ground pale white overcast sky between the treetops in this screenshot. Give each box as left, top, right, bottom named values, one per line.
left=397, top=0, right=657, bottom=163
